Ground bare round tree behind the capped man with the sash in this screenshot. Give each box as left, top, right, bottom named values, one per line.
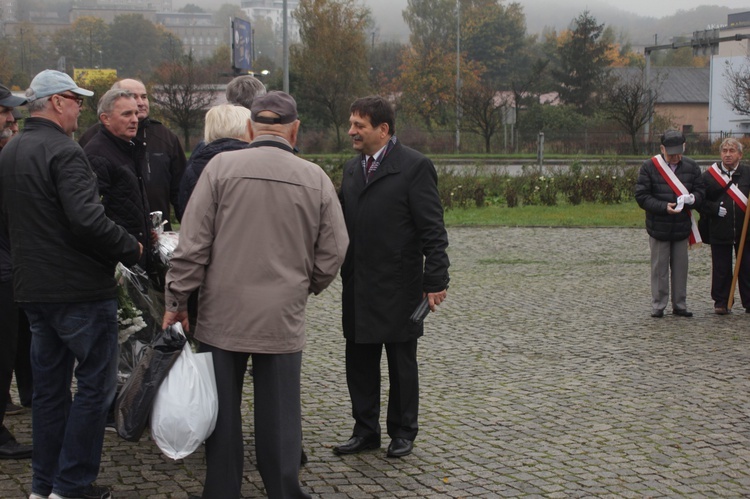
left=602, top=68, right=662, bottom=154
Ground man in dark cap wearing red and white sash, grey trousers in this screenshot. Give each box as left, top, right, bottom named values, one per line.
left=635, top=130, right=706, bottom=317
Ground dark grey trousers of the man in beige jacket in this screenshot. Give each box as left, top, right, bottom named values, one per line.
left=199, top=343, right=310, bottom=499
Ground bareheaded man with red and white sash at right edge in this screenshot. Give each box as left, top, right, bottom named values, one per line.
left=700, top=138, right=750, bottom=315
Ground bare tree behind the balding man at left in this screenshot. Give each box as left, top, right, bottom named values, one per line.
left=151, top=54, right=214, bottom=150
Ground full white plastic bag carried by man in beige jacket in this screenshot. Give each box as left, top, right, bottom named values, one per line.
left=151, top=343, right=219, bottom=459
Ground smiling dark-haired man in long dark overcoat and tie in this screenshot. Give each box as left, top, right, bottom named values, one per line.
left=333, top=96, right=450, bottom=457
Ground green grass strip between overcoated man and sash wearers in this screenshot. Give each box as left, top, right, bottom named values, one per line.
left=445, top=201, right=644, bottom=227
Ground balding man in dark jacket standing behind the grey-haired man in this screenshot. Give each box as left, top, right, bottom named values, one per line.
left=78, top=78, right=186, bottom=230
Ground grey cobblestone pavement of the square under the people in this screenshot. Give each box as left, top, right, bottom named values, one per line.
left=0, top=228, right=750, bottom=499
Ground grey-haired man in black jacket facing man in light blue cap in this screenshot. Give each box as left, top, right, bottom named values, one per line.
left=83, top=90, right=151, bottom=270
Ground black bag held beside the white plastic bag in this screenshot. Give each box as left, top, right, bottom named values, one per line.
left=115, top=324, right=186, bottom=442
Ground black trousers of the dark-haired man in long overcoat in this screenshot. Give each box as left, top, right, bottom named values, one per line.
left=346, top=339, right=419, bottom=441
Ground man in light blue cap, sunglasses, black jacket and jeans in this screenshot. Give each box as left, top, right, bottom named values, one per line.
left=0, top=70, right=142, bottom=499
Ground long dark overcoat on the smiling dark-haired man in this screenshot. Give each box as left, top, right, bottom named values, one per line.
left=340, top=142, right=450, bottom=343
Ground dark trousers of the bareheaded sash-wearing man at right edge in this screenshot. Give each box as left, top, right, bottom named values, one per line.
left=711, top=244, right=750, bottom=308
